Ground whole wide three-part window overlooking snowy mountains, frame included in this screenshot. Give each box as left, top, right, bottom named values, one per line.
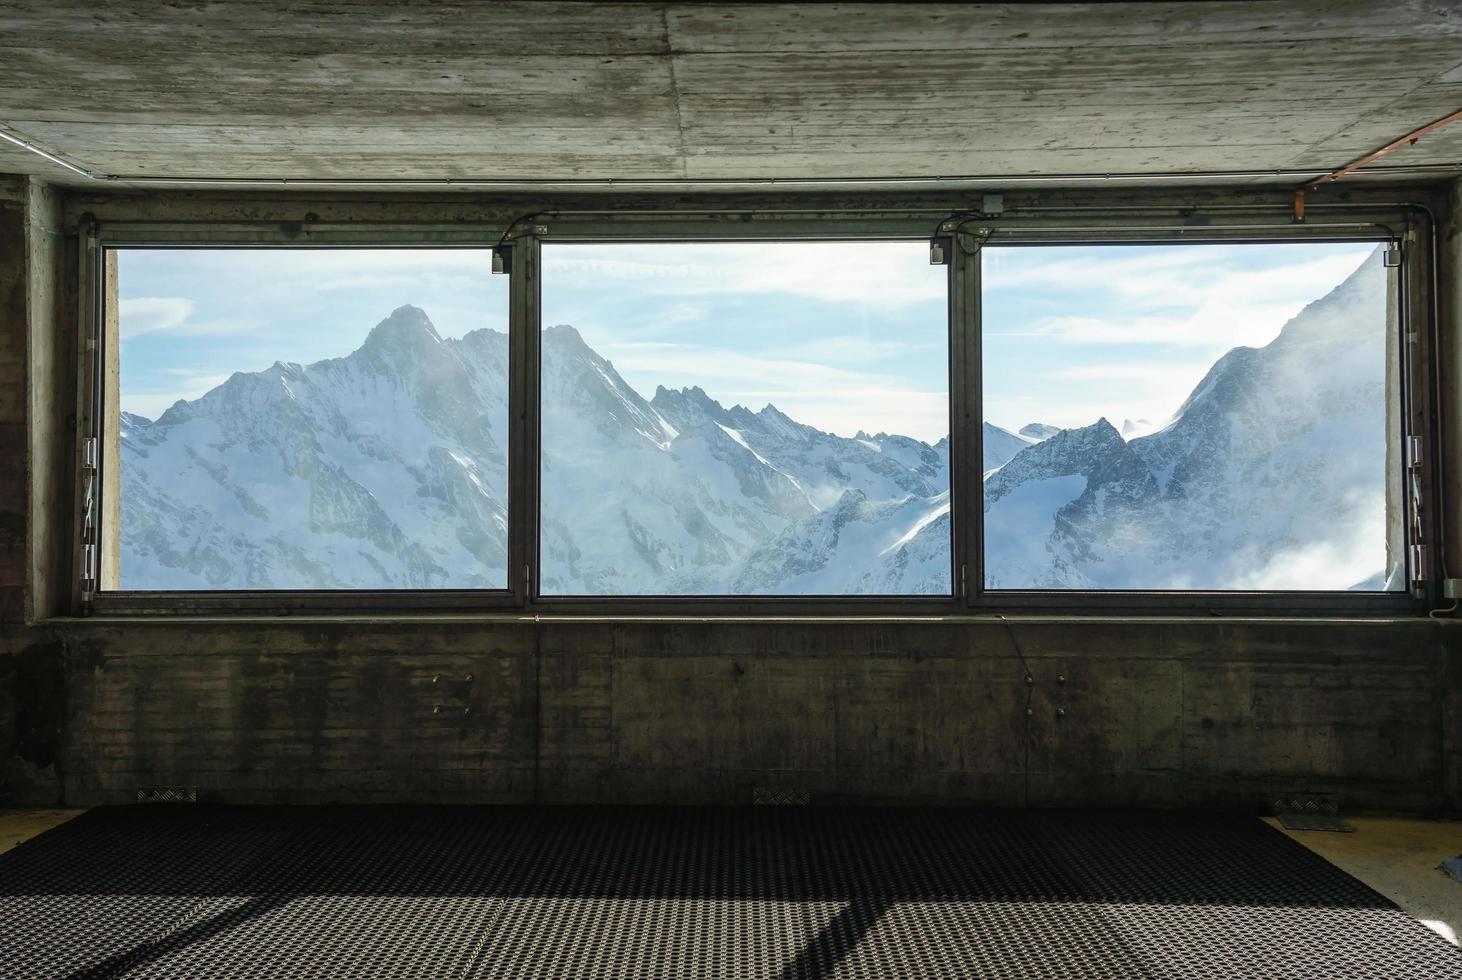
left=76, top=213, right=1439, bottom=616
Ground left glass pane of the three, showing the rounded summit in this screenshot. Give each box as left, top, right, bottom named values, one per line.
left=102, top=249, right=507, bottom=589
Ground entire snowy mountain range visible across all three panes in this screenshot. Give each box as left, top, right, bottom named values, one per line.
left=121, top=250, right=1386, bottom=595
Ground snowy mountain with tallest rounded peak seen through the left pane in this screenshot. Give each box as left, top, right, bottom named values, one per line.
left=121, top=307, right=507, bottom=589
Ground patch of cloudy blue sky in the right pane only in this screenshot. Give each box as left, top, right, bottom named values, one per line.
left=982, top=243, right=1379, bottom=429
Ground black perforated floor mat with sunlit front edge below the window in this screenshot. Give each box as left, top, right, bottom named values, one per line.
left=0, top=806, right=1462, bottom=980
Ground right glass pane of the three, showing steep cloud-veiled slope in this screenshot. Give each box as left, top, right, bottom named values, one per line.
left=982, top=243, right=1404, bottom=591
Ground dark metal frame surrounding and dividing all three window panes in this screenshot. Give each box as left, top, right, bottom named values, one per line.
left=72, top=203, right=1437, bottom=622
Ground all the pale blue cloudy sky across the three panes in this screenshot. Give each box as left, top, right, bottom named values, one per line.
left=118, top=243, right=1374, bottom=440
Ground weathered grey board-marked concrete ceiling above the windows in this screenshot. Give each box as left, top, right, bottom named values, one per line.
left=0, top=0, right=1462, bottom=191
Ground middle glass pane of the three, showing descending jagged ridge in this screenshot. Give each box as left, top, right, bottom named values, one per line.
left=541, top=243, right=950, bottom=595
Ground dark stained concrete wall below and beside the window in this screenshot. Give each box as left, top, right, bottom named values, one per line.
left=0, top=178, right=1462, bottom=812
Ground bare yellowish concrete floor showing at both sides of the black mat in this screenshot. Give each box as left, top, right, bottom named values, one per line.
left=0, top=810, right=1462, bottom=945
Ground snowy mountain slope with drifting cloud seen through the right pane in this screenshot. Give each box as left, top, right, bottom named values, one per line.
left=985, top=255, right=1399, bottom=589
